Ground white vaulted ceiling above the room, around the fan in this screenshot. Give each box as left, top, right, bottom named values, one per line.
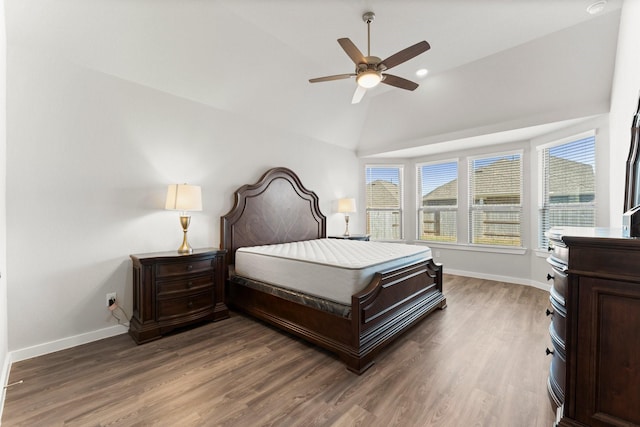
left=6, top=0, right=621, bottom=156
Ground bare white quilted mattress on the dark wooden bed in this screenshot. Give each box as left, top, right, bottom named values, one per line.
left=235, top=239, right=431, bottom=305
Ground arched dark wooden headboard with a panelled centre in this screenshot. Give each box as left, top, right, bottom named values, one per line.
left=220, top=167, right=327, bottom=264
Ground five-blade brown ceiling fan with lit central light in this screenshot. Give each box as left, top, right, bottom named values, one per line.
left=309, top=12, right=431, bottom=104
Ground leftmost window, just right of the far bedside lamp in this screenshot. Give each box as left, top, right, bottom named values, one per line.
left=365, top=165, right=402, bottom=240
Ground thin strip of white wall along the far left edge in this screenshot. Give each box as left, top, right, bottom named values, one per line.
left=0, top=0, right=9, bottom=419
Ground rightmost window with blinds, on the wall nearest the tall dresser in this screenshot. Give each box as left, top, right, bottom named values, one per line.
left=538, top=132, right=596, bottom=249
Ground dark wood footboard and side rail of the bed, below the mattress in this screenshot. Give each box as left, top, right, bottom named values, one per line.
left=227, top=260, right=446, bottom=374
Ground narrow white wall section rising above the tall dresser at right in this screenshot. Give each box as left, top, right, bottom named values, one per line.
left=610, top=0, right=640, bottom=227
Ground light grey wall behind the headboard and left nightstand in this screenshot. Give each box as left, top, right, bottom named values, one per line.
left=7, top=45, right=359, bottom=359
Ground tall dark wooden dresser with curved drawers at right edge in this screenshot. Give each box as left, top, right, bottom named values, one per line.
left=548, top=227, right=640, bottom=427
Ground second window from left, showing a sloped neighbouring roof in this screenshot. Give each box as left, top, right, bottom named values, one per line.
left=416, top=160, right=458, bottom=242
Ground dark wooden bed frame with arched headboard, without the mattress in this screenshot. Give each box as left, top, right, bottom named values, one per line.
left=221, top=168, right=447, bottom=374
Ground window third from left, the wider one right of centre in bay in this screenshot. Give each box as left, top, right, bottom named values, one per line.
left=469, top=153, right=522, bottom=247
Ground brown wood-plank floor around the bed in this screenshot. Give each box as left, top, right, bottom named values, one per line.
left=2, top=275, right=554, bottom=427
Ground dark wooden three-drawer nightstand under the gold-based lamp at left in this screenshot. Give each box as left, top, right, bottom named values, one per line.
left=129, top=249, right=229, bottom=344
